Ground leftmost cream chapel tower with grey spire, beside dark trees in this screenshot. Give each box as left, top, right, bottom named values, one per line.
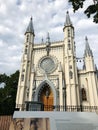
left=16, top=17, right=35, bottom=109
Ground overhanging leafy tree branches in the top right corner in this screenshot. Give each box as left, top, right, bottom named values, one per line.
left=69, top=0, right=98, bottom=23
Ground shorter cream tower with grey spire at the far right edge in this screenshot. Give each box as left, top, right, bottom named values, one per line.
left=84, top=37, right=98, bottom=106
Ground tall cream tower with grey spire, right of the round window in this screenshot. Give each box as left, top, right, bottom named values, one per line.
left=63, top=12, right=79, bottom=106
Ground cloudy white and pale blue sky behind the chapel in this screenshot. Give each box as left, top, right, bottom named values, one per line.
left=0, top=0, right=98, bottom=75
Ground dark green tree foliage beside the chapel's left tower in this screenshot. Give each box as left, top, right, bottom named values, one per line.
left=0, top=71, right=19, bottom=115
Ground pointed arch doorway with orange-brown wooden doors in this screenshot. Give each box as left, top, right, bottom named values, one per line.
left=38, top=83, right=54, bottom=111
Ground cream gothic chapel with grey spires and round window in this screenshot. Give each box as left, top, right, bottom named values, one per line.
left=16, top=12, right=98, bottom=110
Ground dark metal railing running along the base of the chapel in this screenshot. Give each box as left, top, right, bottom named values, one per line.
left=16, top=104, right=98, bottom=112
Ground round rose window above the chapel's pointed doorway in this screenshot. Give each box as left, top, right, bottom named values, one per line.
left=39, top=56, right=56, bottom=73
